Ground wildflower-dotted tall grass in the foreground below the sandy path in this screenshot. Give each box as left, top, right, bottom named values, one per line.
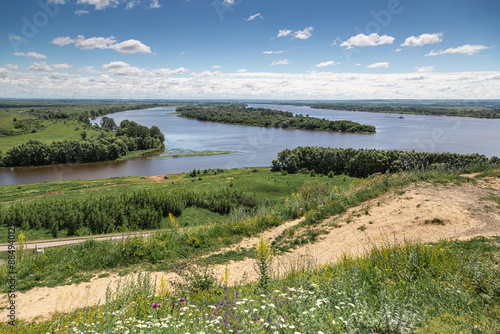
left=0, top=237, right=500, bottom=334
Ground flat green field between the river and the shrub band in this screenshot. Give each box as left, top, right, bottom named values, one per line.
left=0, top=167, right=356, bottom=241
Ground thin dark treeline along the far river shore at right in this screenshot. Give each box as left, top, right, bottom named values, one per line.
left=310, top=103, right=500, bottom=118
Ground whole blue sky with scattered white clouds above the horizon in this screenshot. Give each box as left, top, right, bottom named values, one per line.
left=0, top=0, right=500, bottom=99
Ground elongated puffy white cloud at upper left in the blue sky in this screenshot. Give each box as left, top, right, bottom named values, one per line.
left=52, top=35, right=151, bottom=53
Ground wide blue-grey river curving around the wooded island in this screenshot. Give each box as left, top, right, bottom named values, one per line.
left=0, top=104, right=500, bottom=185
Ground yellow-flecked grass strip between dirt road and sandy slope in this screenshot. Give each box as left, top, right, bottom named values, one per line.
left=0, top=167, right=474, bottom=291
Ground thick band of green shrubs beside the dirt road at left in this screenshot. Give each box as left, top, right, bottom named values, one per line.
left=0, top=188, right=243, bottom=237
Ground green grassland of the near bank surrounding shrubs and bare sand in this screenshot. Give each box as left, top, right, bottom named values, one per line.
left=0, top=162, right=500, bottom=334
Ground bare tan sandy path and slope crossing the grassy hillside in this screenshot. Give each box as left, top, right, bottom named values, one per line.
left=0, top=178, right=500, bottom=320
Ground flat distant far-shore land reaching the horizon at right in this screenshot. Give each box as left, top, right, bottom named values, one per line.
left=296, top=100, right=500, bottom=118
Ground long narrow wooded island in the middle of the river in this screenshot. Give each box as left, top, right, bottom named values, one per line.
left=177, top=105, right=375, bottom=133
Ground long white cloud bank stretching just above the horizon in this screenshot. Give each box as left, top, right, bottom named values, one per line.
left=0, top=68, right=500, bottom=100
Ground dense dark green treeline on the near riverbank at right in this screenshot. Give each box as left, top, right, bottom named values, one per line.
left=272, top=146, right=500, bottom=177
